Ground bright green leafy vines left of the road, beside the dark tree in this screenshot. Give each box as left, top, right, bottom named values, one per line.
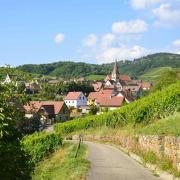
left=21, top=132, right=62, bottom=164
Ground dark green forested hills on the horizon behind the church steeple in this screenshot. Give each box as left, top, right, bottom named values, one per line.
left=17, top=53, right=180, bottom=78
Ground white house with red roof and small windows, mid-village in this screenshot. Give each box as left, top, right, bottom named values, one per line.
left=64, top=92, right=87, bottom=108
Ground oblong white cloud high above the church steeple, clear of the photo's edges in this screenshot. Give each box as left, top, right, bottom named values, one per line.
left=112, top=19, right=148, bottom=34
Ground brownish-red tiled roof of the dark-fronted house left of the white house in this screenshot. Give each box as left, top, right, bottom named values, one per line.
left=24, top=101, right=64, bottom=114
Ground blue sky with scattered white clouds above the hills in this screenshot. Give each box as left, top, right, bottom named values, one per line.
left=0, top=0, right=180, bottom=66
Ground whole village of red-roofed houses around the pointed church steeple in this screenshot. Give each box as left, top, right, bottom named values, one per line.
left=1, top=61, right=152, bottom=128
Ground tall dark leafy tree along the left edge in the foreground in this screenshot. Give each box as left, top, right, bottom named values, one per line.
left=0, top=84, right=32, bottom=180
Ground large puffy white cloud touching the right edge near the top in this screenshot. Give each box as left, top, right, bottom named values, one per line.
left=152, top=3, right=180, bottom=27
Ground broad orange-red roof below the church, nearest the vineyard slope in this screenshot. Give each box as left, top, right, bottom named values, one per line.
left=98, top=96, right=124, bottom=107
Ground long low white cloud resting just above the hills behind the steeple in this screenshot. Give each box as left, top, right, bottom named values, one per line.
left=96, top=45, right=150, bottom=64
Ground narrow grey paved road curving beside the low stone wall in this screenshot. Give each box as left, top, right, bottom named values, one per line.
left=85, top=142, right=160, bottom=180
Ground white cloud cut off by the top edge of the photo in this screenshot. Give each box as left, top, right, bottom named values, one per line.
left=130, top=0, right=162, bottom=9
